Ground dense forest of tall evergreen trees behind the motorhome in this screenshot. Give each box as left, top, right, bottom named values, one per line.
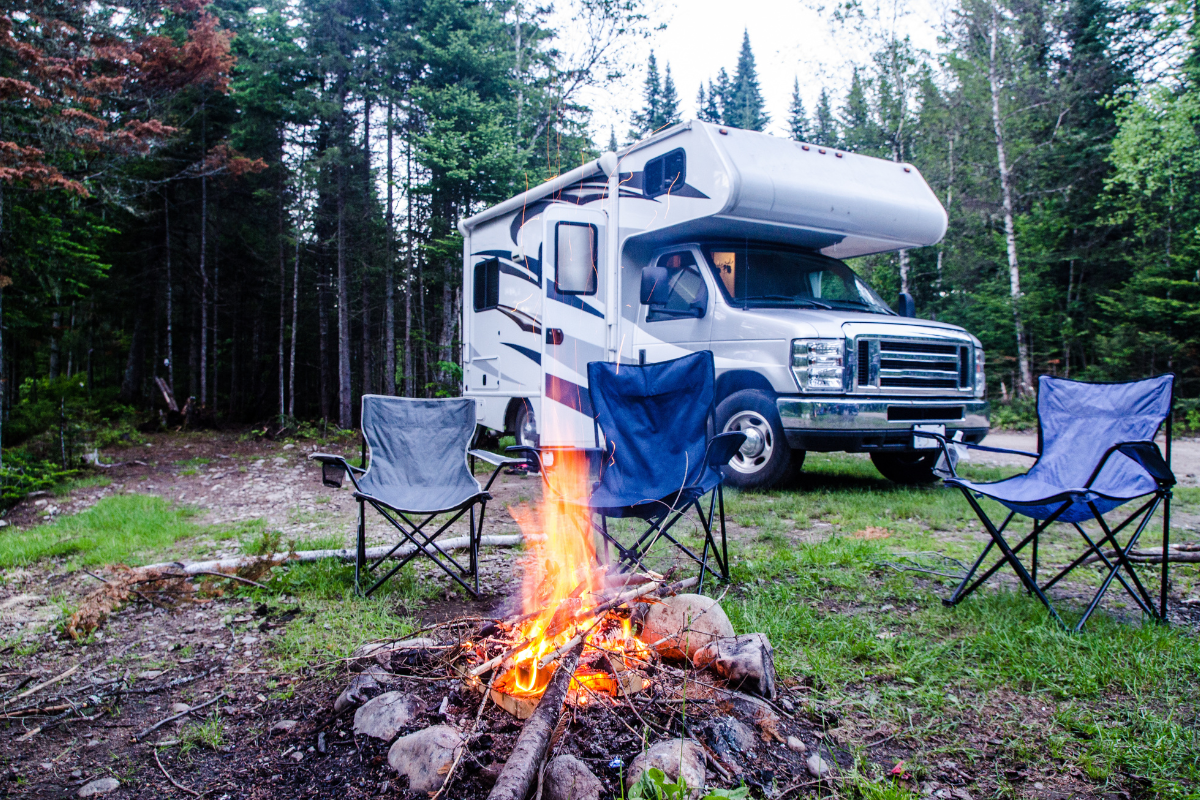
left=0, top=0, right=1200, bottom=470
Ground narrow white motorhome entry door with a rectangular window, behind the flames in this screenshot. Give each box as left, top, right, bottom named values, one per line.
left=538, top=203, right=611, bottom=447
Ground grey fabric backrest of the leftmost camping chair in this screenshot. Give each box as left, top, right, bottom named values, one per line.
left=360, top=395, right=479, bottom=491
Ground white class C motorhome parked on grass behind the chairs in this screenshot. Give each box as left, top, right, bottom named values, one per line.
left=458, top=121, right=988, bottom=487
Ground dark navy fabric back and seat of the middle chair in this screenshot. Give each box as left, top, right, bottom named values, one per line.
left=588, top=350, right=716, bottom=505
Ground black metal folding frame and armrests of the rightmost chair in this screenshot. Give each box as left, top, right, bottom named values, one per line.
left=916, top=412, right=1175, bottom=633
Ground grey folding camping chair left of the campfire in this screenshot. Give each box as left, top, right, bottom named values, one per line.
left=308, top=395, right=522, bottom=597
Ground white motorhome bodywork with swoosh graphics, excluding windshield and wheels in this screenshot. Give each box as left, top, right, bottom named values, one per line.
left=458, top=122, right=986, bottom=479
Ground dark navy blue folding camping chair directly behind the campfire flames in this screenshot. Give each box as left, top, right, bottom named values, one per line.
left=509, top=350, right=745, bottom=590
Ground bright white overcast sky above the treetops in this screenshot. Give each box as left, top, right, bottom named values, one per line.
left=566, top=0, right=943, bottom=148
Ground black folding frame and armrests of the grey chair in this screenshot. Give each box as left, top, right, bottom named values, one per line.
left=310, top=448, right=523, bottom=597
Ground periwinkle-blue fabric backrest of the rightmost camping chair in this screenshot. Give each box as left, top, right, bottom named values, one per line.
left=1030, top=374, right=1175, bottom=497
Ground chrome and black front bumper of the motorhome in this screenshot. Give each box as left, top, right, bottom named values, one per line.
left=775, top=396, right=988, bottom=452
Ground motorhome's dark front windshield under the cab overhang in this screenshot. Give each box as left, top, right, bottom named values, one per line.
left=704, top=243, right=894, bottom=314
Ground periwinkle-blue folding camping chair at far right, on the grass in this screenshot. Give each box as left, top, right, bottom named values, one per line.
left=917, top=374, right=1175, bottom=632
